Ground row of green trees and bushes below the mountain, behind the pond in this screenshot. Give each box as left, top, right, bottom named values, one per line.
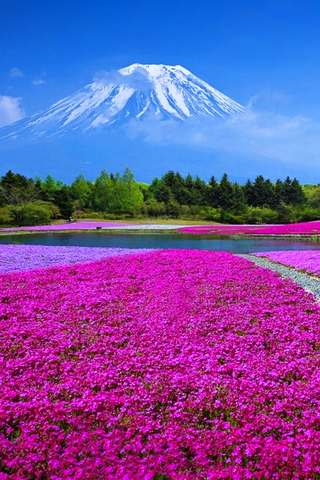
left=0, top=168, right=320, bottom=225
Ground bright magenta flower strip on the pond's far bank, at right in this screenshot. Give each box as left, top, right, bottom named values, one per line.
left=179, top=221, right=320, bottom=235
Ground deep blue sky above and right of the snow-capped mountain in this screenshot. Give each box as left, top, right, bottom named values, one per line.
left=0, top=0, right=320, bottom=182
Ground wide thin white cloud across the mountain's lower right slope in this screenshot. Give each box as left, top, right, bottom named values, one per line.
left=125, top=102, right=320, bottom=167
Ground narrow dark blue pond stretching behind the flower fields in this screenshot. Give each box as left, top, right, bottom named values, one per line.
left=0, top=232, right=320, bottom=253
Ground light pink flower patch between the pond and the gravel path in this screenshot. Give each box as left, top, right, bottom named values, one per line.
left=254, top=250, right=320, bottom=276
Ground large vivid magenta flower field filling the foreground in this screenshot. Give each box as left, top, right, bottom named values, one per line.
left=0, top=250, right=320, bottom=480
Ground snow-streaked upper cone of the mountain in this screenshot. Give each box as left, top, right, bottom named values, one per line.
left=0, top=63, right=243, bottom=139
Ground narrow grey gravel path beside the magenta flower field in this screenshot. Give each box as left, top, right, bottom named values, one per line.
left=238, top=254, right=320, bottom=299
